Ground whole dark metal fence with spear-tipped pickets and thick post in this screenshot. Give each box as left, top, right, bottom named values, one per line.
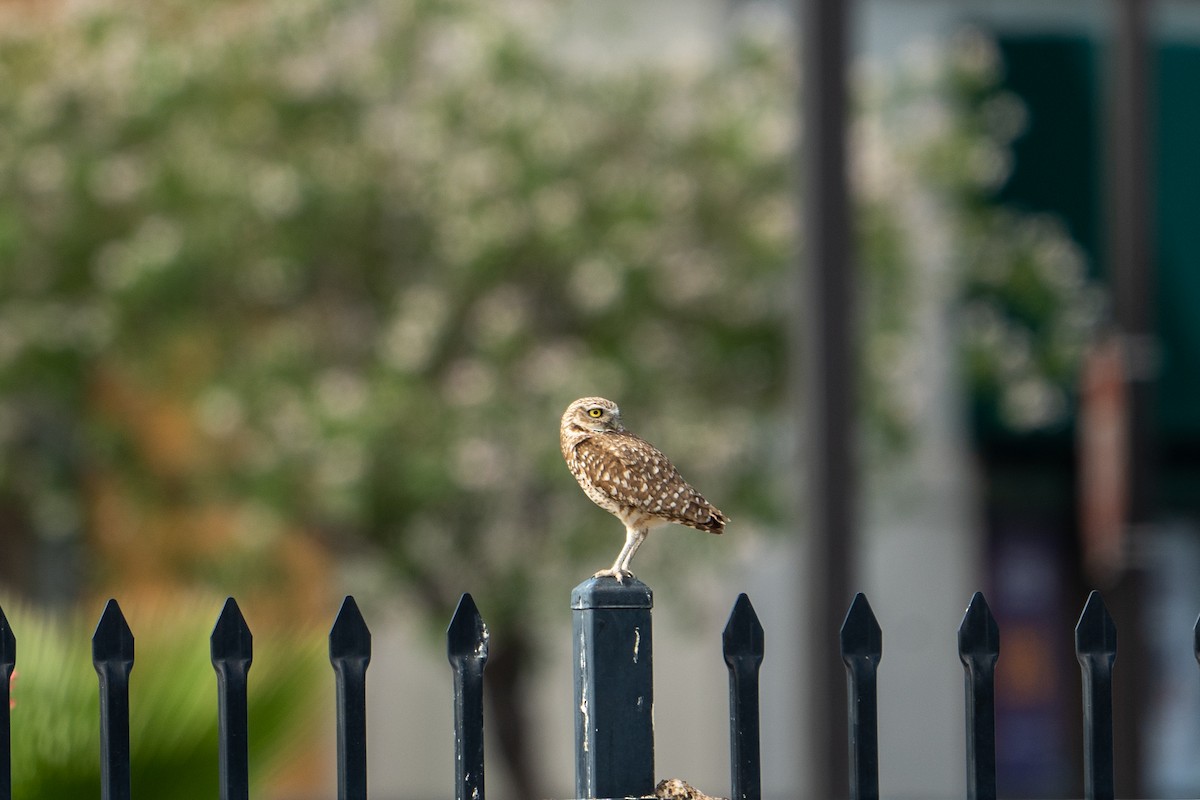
left=0, top=578, right=1200, bottom=800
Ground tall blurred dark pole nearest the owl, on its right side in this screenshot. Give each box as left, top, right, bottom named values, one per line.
left=793, top=0, right=857, bottom=798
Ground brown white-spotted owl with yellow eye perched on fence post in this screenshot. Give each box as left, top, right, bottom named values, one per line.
left=559, top=397, right=726, bottom=581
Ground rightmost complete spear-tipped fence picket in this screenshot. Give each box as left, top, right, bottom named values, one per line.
left=1075, top=591, right=1117, bottom=800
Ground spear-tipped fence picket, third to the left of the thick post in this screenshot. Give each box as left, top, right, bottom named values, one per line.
left=209, top=597, right=254, bottom=800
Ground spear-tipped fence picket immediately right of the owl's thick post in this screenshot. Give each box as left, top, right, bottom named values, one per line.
left=721, top=594, right=764, bottom=800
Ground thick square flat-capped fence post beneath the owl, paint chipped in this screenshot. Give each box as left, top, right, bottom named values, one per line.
left=571, top=577, right=654, bottom=798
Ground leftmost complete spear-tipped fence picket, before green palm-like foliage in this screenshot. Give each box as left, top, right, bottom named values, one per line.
left=91, top=600, right=133, bottom=800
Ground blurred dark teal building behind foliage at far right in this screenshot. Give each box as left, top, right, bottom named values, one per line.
left=863, top=0, right=1200, bottom=796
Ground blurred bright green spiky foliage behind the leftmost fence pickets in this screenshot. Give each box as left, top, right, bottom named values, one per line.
left=5, top=602, right=332, bottom=800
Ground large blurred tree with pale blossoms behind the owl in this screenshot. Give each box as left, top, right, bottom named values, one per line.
left=0, top=0, right=1099, bottom=796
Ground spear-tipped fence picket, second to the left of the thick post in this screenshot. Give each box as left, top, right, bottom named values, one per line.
left=329, top=595, right=371, bottom=800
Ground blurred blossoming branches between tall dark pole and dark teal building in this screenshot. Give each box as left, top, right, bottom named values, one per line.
left=884, top=29, right=1106, bottom=433
